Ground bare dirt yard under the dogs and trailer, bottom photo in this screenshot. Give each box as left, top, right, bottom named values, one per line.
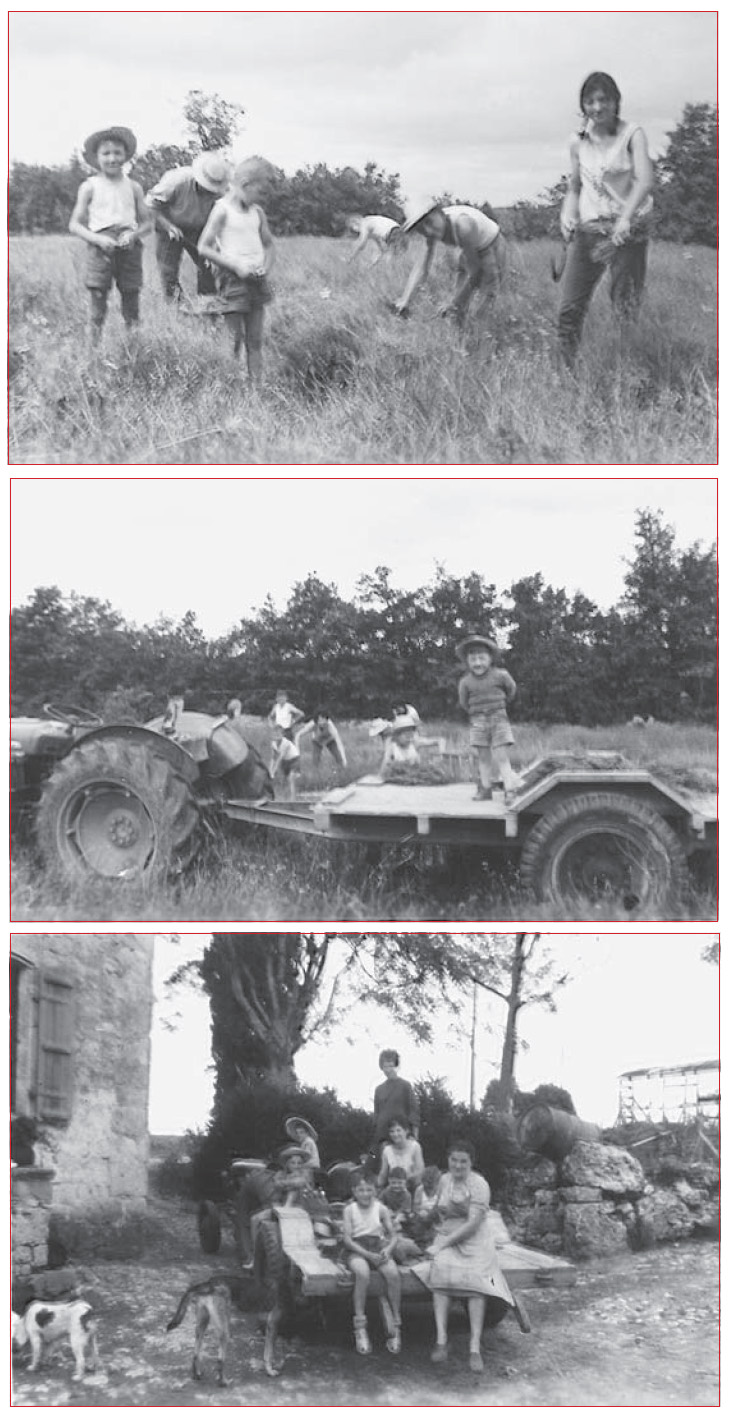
left=14, top=1202, right=719, bottom=1407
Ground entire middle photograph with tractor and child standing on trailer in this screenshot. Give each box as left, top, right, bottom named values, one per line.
left=11, top=476, right=718, bottom=925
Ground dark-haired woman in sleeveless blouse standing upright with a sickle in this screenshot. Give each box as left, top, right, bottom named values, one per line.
left=557, top=72, right=652, bottom=366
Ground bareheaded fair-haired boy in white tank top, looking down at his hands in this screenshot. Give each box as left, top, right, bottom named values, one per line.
left=197, top=157, right=274, bottom=384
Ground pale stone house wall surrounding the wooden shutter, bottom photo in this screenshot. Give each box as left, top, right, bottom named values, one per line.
left=11, top=934, right=153, bottom=1259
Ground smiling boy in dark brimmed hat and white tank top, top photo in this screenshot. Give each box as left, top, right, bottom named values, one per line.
left=68, top=126, right=152, bottom=345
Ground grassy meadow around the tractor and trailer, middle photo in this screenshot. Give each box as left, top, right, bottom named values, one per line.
left=11, top=719, right=716, bottom=923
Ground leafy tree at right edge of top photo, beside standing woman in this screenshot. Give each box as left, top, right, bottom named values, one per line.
left=657, top=104, right=719, bottom=247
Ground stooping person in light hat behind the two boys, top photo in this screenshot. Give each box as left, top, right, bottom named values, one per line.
left=146, top=153, right=230, bottom=301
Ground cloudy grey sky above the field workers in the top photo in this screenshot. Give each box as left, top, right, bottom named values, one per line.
left=10, top=10, right=716, bottom=204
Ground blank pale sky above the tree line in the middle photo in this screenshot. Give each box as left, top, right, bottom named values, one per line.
left=11, top=476, right=716, bottom=637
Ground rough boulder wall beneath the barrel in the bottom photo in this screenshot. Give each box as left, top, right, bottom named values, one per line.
left=499, top=1143, right=719, bottom=1259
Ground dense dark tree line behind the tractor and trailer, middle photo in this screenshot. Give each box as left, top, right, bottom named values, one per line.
left=11, top=510, right=718, bottom=726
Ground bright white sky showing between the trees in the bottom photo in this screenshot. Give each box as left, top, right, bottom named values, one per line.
left=150, top=934, right=719, bottom=1133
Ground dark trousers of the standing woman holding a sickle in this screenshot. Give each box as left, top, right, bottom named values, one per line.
left=557, top=230, right=648, bottom=364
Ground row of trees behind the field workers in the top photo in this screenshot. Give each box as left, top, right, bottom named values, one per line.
left=9, top=89, right=718, bottom=245
